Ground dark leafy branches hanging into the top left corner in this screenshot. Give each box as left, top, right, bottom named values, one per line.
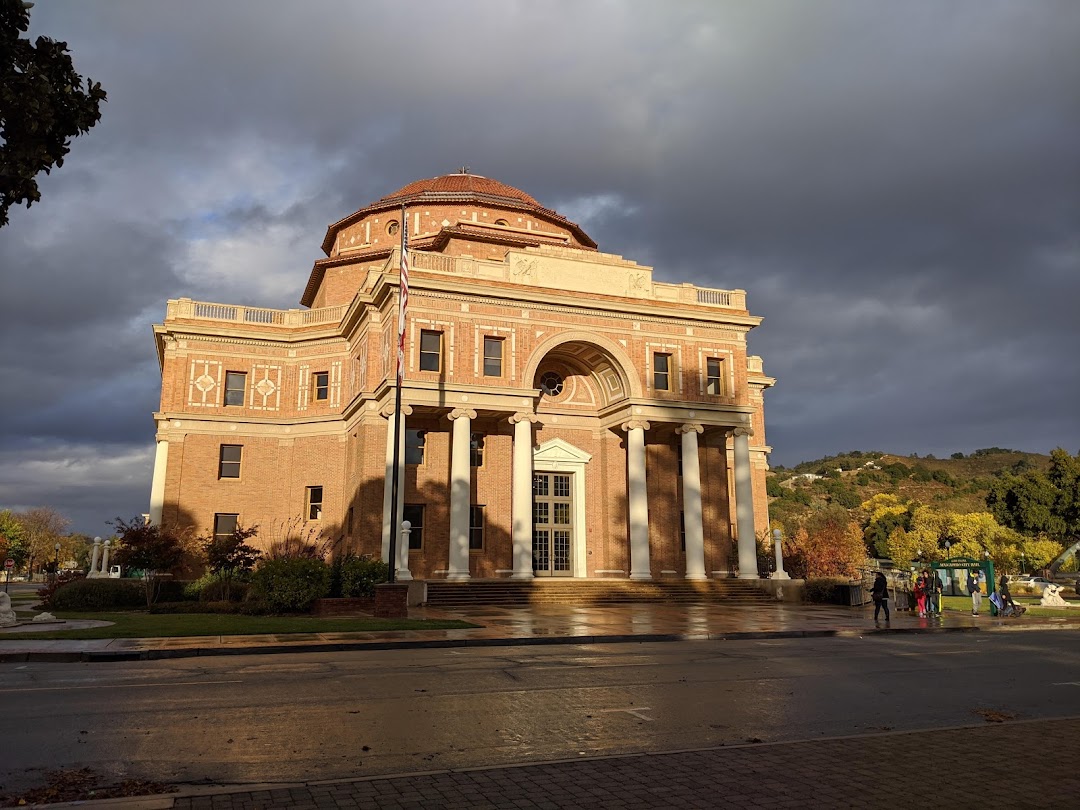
left=0, top=0, right=106, bottom=228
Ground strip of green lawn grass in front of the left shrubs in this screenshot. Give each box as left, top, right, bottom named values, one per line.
left=0, top=611, right=478, bottom=645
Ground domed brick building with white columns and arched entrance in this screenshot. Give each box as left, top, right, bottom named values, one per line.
left=150, top=173, right=773, bottom=580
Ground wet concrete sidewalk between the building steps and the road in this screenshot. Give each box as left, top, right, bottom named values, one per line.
left=0, top=603, right=1080, bottom=662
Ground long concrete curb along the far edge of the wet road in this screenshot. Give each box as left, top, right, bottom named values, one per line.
left=0, top=625, right=1010, bottom=663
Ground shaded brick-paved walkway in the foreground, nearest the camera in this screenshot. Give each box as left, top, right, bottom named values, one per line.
left=173, top=718, right=1080, bottom=810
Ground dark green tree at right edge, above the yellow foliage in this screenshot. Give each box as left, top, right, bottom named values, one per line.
left=986, top=447, right=1080, bottom=542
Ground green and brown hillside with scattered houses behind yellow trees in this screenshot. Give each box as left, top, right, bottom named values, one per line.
left=768, top=447, right=1050, bottom=527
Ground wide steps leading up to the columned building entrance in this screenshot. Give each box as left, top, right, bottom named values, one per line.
left=426, top=579, right=775, bottom=608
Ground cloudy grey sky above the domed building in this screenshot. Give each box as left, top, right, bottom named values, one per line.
left=0, top=0, right=1080, bottom=535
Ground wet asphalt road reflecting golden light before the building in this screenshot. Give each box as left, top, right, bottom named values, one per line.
left=0, top=632, right=1080, bottom=792
